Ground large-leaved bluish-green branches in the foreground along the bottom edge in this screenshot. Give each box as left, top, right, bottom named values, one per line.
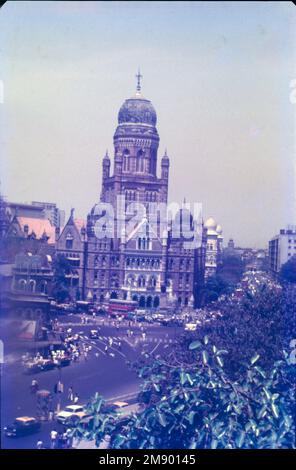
left=76, top=337, right=295, bottom=449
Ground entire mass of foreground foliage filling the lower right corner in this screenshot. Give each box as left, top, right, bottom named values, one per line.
left=72, top=285, right=296, bottom=449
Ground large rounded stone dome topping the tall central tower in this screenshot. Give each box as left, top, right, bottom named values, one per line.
left=118, top=92, right=157, bottom=127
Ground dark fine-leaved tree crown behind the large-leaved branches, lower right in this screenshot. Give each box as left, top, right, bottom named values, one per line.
left=184, top=285, right=296, bottom=377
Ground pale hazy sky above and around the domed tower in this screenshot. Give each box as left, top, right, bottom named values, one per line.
left=0, top=1, right=296, bottom=247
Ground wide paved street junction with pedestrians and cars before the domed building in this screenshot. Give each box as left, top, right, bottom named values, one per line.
left=2, top=314, right=183, bottom=448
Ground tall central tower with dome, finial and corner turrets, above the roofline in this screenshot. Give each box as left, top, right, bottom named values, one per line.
left=101, top=73, right=169, bottom=208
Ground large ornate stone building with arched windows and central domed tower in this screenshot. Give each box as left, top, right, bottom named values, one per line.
left=56, top=81, right=206, bottom=308
